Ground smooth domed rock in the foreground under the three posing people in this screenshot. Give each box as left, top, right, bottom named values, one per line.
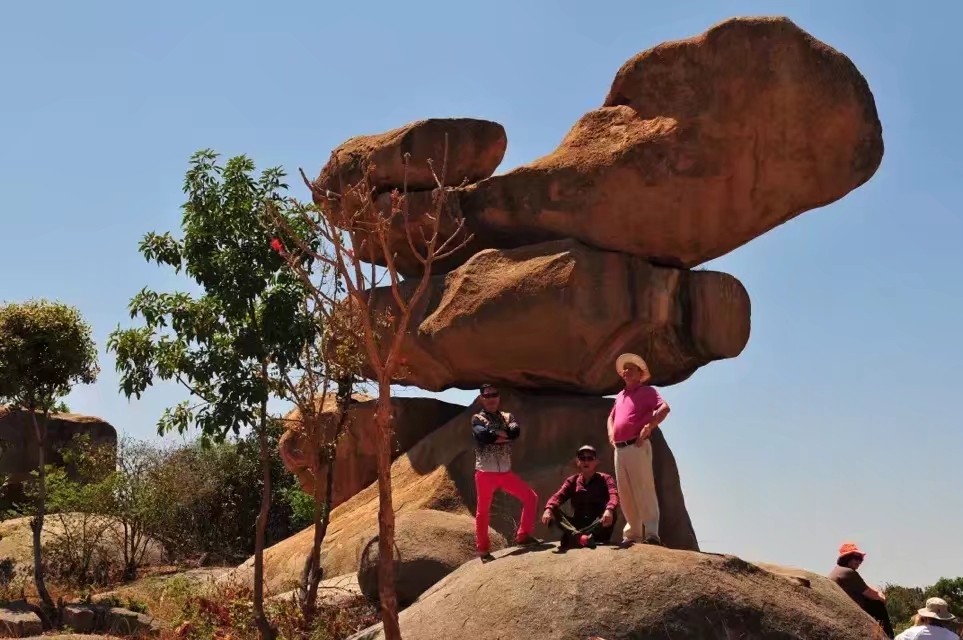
left=352, top=546, right=885, bottom=640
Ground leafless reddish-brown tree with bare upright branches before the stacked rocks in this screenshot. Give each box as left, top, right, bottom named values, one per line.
left=275, top=135, right=472, bottom=640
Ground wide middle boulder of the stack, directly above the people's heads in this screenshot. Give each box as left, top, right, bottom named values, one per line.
left=366, top=240, right=750, bottom=395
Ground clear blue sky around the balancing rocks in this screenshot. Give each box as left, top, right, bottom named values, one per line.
left=0, top=0, right=963, bottom=584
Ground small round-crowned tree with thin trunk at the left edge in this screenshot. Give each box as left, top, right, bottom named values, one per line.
left=0, top=300, right=100, bottom=609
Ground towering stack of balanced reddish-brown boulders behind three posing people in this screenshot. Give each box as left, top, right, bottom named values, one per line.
left=266, top=18, right=883, bottom=592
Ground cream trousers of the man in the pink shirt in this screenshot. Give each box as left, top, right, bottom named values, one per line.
left=615, top=440, right=659, bottom=541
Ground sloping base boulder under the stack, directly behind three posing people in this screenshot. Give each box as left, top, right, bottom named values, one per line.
left=234, top=390, right=699, bottom=593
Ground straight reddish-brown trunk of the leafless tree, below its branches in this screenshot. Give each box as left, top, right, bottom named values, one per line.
left=375, top=382, right=401, bottom=640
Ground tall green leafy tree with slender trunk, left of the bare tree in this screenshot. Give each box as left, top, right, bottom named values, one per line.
left=109, top=150, right=314, bottom=638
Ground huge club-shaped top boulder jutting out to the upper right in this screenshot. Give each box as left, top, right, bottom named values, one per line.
left=330, top=17, right=883, bottom=275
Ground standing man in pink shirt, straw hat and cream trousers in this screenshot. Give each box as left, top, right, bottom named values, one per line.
left=608, top=353, right=669, bottom=546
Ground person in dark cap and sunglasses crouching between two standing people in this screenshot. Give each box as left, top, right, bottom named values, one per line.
left=542, top=445, right=619, bottom=549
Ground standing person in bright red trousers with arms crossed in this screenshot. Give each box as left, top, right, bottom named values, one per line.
left=471, top=385, right=540, bottom=562
